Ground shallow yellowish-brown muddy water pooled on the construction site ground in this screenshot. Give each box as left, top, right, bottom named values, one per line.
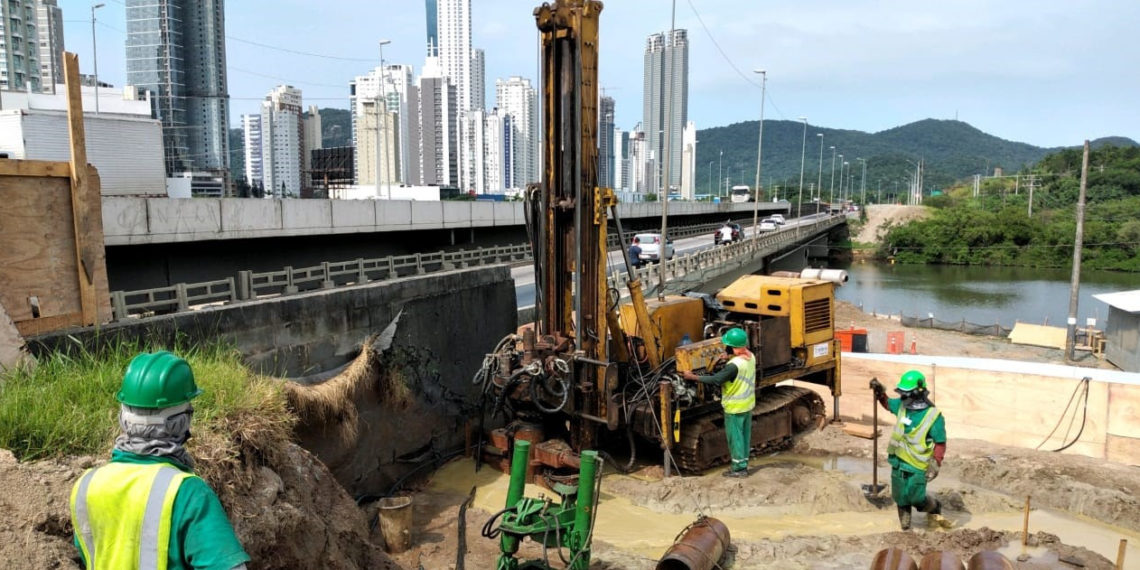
left=431, top=454, right=1140, bottom=570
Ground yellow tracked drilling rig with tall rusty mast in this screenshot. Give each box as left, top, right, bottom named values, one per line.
left=474, top=0, right=840, bottom=487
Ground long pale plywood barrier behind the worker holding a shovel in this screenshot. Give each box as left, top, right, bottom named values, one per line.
left=802, top=353, right=1140, bottom=465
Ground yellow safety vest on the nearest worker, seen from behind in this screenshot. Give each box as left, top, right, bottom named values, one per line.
left=71, top=463, right=195, bottom=570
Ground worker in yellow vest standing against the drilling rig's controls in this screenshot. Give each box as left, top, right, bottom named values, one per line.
left=682, top=327, right=756, bottom=477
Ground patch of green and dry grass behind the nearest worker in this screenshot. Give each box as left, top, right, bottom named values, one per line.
left=0, top=344, right=285, bottom=461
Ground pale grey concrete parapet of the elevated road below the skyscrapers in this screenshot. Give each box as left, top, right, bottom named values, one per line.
left=103, top=196, right=787, bottom=245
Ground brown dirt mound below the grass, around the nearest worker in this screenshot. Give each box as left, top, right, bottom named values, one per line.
left=0, top=443, right=398, bottom=569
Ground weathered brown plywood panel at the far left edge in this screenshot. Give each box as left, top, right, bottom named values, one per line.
left=0, top=177, right=81, bottom=324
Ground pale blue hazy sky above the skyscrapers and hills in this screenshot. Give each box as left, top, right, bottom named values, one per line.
left=59, top=0, right=1140, bottom=147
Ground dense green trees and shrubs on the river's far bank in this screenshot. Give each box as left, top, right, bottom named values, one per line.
left=879, top=145, right=1140, bottom=271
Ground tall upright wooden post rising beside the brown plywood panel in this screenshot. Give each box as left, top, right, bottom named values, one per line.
left=64, top=51, right=103, bottom=325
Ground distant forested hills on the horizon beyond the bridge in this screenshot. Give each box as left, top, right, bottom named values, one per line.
left=697, top=119, right=1076, bottom=201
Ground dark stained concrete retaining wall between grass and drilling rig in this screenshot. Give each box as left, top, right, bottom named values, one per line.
left=30, top=266, right=515, bottom=496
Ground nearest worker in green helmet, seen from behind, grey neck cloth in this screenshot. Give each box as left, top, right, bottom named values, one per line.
left=71, top=351, right=250, bottom=570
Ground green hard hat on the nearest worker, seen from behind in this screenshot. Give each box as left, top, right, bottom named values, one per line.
left=115, top=350, right=202, bottom=409
